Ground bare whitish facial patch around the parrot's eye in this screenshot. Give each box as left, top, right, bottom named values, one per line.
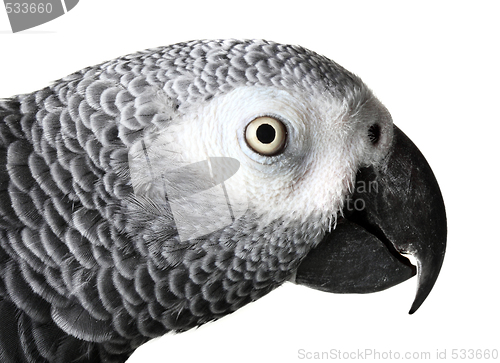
left=129, top=86, right=388, bottom=240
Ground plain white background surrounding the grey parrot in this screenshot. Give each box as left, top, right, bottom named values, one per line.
left=0, top=0, right=500, bottom=363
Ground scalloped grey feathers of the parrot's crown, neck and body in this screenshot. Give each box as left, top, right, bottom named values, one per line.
left=0, top=40, right=390, bottom=362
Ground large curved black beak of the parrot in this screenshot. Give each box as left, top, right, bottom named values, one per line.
left=295, top=126, right=447, bottom=314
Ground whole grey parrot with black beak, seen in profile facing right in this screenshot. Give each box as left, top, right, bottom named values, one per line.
left=0, top=40, right=446, bottom=363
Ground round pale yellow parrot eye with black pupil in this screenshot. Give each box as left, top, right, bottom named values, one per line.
left=245, top=116, right=287, bottom=156
